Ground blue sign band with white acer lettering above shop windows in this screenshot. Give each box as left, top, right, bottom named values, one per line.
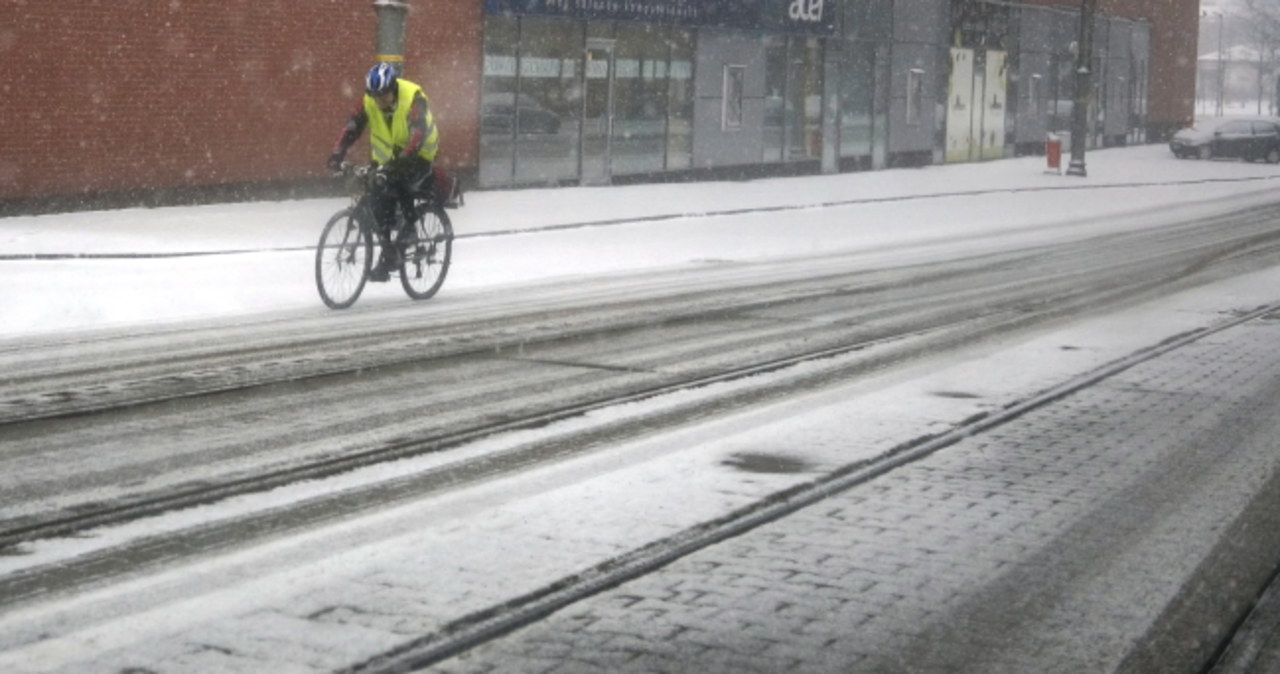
left=484, top=0, right=837, bottom=35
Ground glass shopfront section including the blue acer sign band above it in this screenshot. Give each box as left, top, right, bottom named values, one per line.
left=479, top=0, right=835, bottom=187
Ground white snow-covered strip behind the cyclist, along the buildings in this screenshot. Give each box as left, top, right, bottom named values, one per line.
left=0, top=146, right=1280, bottom=338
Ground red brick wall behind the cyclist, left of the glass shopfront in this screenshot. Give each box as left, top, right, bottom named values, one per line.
left=0, top=0, right=481, bottom=200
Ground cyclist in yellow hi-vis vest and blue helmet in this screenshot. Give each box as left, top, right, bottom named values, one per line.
left=328, top=63, right=440, bottom=281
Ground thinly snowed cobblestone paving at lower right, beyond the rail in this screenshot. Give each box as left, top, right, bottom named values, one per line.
left=430, top=320, right=1280, bottom=673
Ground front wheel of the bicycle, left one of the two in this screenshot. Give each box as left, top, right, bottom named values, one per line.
left=316, top=208, right=372, bottom=310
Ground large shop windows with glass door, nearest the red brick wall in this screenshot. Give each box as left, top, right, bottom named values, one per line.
left=480, top=15, right=694, bottom=185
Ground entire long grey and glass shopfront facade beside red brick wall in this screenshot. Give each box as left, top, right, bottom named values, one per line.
left=477, top=0, right=1149, bottom=187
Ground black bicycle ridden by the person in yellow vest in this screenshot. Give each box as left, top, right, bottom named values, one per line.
left=316, top=164, right=462, bottom=310
